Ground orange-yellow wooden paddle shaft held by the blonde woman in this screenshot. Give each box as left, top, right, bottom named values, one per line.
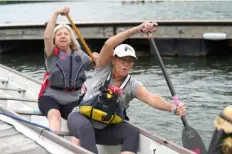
left=66, top=14, right=94, bottom=60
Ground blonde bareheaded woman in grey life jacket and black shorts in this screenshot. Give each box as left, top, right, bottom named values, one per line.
left=38, top=7, right=96, bottom=142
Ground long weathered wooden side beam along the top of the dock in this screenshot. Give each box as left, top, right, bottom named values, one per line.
left=0, top=20, right=232, bottom=40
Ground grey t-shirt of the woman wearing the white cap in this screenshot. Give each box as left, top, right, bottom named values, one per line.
left=74, top=62, right=142, bottom=129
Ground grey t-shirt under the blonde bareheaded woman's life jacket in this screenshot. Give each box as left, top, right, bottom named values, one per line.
left=43, top=51, right=91, bottom=105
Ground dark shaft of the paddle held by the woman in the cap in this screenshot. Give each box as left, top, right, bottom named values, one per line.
left=148, top=37, right=188, bottom=127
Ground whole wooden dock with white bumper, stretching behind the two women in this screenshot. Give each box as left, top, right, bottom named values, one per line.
left=0, top=20, right=232, bottom=56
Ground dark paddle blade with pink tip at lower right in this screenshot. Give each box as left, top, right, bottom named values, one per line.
left=182, top=126, right=207, bottom=154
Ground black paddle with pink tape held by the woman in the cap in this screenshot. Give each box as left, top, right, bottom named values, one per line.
left=148, top=33, right=207, bottom=154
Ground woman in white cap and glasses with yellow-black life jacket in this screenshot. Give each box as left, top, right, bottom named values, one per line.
left=68, top=22, right=186, bottom=154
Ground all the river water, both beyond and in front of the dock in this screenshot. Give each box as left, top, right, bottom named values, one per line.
left=0, top=1, right=232, bottom=151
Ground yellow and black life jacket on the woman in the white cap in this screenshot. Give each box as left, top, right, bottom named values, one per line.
left=79, top=73, right=130, bottom=124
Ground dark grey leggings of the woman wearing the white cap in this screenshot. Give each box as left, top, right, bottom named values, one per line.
left=68, top=112, right=139, bottom=154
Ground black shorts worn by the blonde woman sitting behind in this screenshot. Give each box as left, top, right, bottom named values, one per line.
left=38, top=96, right=80, bottom=120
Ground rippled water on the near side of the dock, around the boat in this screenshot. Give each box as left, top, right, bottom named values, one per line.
left=0, top=52, right=232, bottom=146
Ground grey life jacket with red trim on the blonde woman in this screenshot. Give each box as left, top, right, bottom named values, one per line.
left=38, top=48, right=86, bottom=99
